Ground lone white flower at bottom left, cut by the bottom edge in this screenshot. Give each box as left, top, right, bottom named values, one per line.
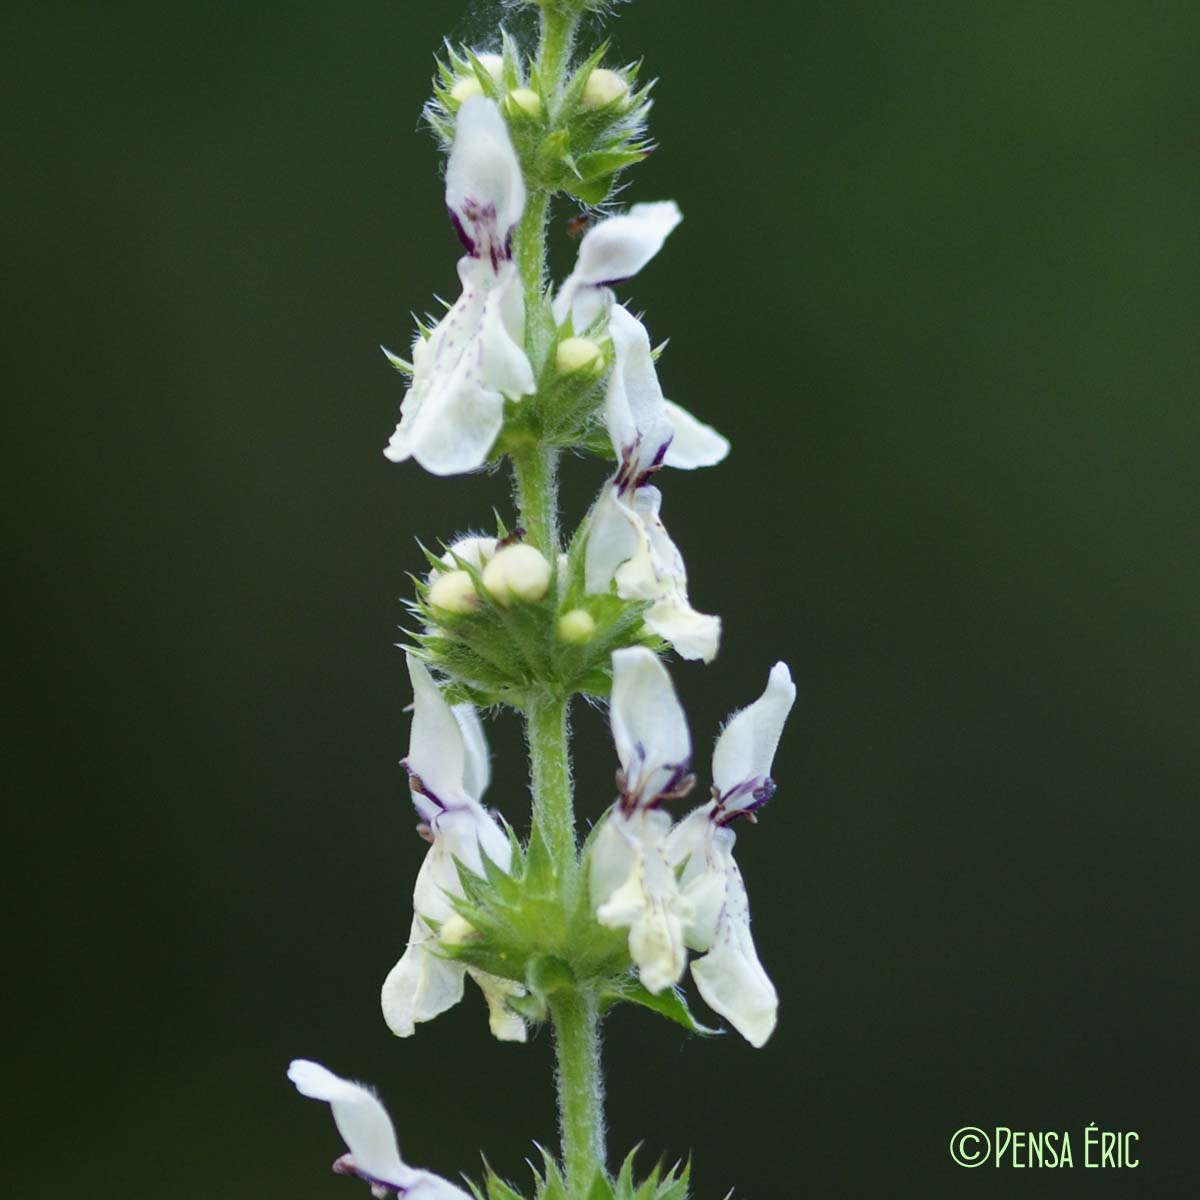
left=288, top=1058, right=469, bottom=1200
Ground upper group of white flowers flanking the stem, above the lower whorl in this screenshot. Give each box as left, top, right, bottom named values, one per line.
left=384, top=95, right=728, bottom=661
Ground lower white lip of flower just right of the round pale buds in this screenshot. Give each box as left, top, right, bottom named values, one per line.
left=583, top=444, right=721, bottom=662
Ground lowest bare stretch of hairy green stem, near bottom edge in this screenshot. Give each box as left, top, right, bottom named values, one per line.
left=550, top=991, right=605, bottom=1200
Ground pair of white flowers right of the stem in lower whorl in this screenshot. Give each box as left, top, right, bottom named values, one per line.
left=590, top=647, right=796, bottom=1046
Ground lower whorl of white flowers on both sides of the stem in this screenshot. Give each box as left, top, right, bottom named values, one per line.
left=369, top=647, right=796, bottom=1046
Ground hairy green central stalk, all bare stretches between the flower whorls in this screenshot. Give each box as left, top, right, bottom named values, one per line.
left=511, top=0, right=605, bottom=1200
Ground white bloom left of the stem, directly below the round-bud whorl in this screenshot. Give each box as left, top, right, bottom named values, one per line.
left=380, top=655, right=526, bottom=1042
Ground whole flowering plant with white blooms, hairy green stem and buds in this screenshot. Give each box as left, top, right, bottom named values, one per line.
left=289, top=0, right=796, bottom=1200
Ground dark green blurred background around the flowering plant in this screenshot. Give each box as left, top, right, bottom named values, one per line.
left=0, top=0, right=1200, bottom=1200
